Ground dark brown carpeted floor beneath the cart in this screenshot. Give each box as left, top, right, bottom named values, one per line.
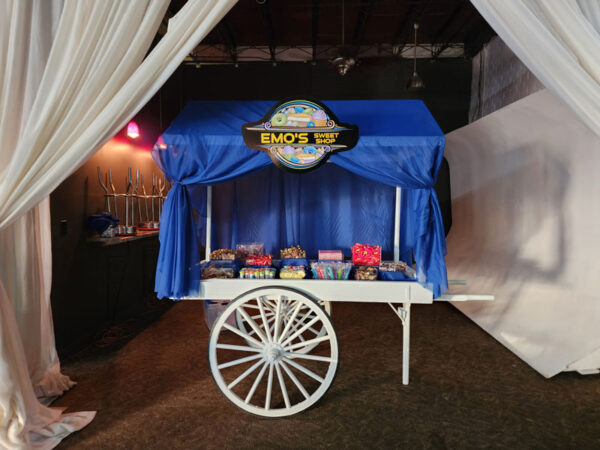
left=54, top=302, right=600, bottom=449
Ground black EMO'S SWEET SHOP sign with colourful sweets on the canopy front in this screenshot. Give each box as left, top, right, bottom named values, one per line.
left=242, top=100, right=358, bottom=172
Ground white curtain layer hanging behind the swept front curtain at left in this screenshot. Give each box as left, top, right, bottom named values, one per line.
left=0, top=0, right=74, bottom=403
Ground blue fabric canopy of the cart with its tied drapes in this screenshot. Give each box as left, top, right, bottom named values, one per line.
left=152, top=100, right=448, bottom=298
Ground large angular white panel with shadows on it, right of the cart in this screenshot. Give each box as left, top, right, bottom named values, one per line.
left=444, top=89, right=600, bottom=381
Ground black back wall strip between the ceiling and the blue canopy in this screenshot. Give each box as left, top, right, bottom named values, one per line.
left=157, top=58, right=471, bottom=133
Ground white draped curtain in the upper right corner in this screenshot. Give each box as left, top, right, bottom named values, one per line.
left=471, top=0, right=600, bottom=135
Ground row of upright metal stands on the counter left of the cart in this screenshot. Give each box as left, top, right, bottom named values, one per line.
left=97, top=167, right=171, bottom=236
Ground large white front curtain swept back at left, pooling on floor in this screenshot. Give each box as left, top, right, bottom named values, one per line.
left=0, top=0, right=235, bottom=448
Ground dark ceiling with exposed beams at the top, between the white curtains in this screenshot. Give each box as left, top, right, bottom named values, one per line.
left=168, top=0, right=494, bottom=59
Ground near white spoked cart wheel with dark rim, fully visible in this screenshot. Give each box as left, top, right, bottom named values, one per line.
left=208, top=287, right=339, bottom=417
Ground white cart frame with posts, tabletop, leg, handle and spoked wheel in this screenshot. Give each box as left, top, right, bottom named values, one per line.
left=185, top=188, right=494, bottom=417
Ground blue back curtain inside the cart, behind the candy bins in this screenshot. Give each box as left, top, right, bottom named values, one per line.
left=191, top=164, right=412, bottom=260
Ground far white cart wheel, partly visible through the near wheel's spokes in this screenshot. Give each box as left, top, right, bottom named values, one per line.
left=235, top=298, right=331, bottom=353
